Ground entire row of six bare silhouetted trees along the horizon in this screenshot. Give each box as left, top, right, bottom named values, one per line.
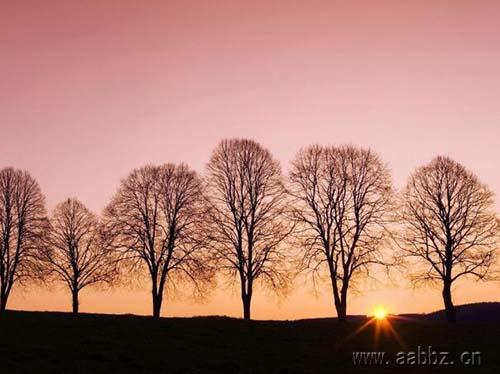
left=0, top=139, right=500, bottom=321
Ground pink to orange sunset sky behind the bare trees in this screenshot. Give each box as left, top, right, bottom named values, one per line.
left=0, top=0, right=500, bottom=319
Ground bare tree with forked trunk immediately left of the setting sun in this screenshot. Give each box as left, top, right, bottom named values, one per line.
left=290, top=146, right=392, bottom=321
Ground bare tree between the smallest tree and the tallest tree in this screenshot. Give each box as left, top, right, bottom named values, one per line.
left=105, top=164, right=211, bottom=317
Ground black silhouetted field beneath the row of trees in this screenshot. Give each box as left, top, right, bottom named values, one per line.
left=0, top=311, right=500, bottom=374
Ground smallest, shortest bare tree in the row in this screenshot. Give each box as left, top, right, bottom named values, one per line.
left=42, top=199, right=117, bottom=314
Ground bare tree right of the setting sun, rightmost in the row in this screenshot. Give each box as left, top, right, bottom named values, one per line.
left=400, top=156, right=499, bottom=322
